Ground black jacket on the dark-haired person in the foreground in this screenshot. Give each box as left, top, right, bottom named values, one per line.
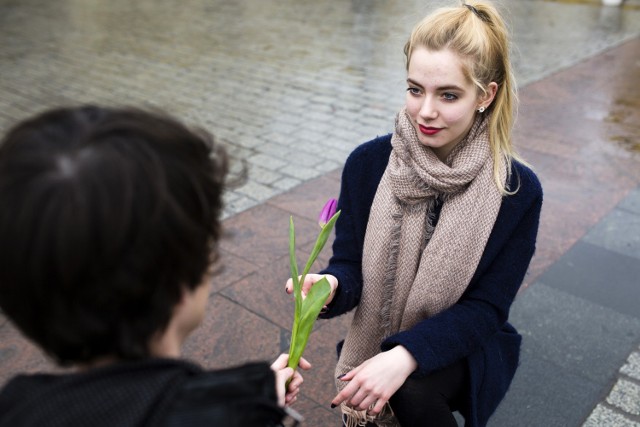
left=0, top=359, right=285, bottom=427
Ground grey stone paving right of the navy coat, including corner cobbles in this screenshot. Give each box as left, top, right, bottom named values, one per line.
left=490, top=187, right=640, bottom=427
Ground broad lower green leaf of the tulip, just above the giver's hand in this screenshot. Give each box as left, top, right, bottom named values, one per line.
left=288, top=277, right=331, bottom=370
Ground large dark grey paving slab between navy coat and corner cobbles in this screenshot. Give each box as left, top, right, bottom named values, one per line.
left=490, top=282, right=640, bottom=427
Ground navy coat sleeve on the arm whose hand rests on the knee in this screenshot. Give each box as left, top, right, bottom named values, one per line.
left=381, top=165, right=542, bottom=376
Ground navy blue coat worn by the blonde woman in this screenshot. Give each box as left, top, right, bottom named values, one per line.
left=321, top=135, right=542, bottom=426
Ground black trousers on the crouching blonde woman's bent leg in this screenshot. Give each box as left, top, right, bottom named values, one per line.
left=344, top=359, right=469, bottom=427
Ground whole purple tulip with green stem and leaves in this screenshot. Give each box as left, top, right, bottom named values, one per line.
left=288, top=199, right=340, bottom=370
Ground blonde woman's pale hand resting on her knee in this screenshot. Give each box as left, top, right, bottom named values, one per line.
left=331, top=346, right=418, bottom=415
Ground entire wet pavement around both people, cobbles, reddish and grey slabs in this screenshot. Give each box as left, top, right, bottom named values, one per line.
left=0, top=0, right=640, bottom=426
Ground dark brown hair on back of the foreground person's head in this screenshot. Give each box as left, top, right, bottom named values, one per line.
left=0, top=106, right=227, bottom=364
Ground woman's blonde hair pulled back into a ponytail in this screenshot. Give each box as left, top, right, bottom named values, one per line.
left=404, top=1, right=526, bottom=194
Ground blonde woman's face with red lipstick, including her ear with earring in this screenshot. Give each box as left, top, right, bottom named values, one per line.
left=406, top=47, right=497, bottom=161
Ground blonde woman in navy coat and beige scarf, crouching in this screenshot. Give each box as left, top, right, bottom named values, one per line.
left=287, top=1, right=542, bottom=427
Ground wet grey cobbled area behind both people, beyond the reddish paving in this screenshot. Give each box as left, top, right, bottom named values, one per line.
left=0, top=0, right=640, bottom=217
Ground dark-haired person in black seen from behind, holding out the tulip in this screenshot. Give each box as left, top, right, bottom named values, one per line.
left=0, top=106, right=309, bottom=427
